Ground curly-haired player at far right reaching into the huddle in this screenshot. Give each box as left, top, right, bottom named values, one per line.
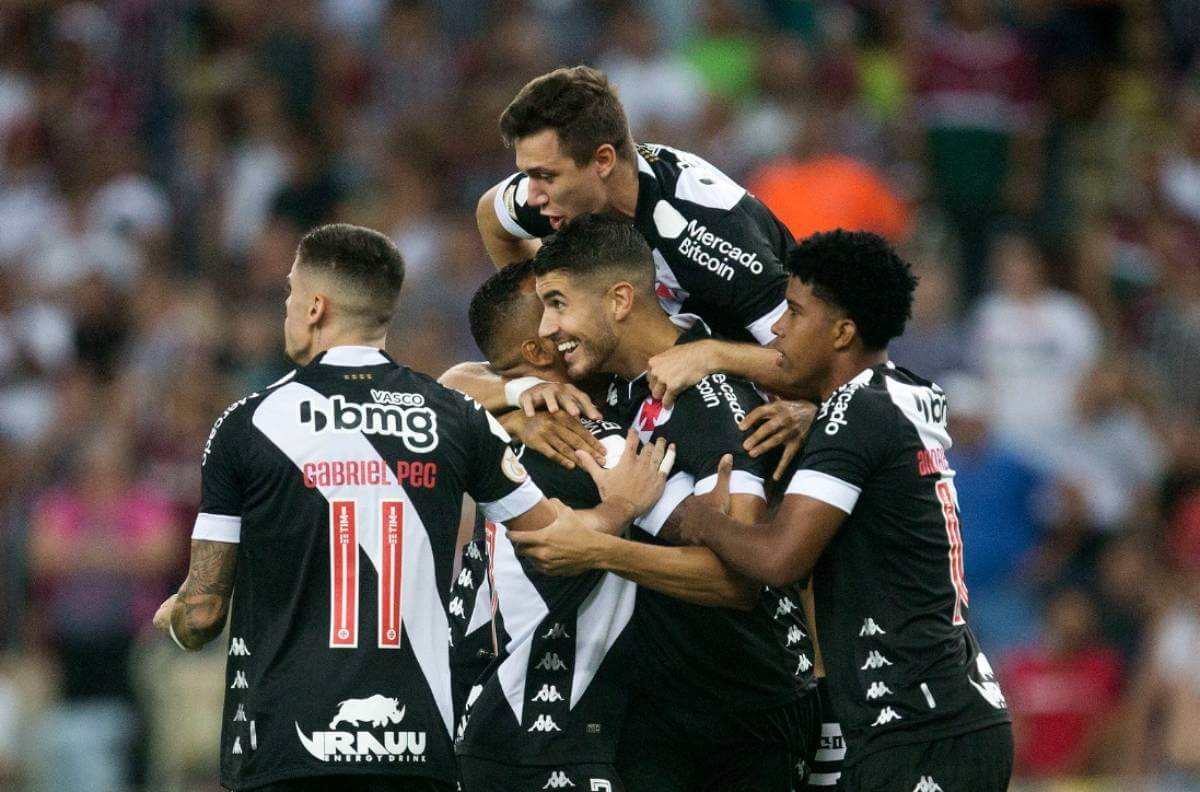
left=683, top=230, right=1013, bottom=792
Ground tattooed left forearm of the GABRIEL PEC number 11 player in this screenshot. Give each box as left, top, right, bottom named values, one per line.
left=170, top=539, right=238, bottom=649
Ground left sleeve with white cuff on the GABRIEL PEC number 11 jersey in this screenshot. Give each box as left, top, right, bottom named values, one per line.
left=192, top=402, right=250, bottom=542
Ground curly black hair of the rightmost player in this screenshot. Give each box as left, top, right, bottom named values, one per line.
left=787, top=228, right=918, bottom=349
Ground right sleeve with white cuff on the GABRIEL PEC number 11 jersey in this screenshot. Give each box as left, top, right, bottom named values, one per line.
left=466, top=403, right=544, bottom=522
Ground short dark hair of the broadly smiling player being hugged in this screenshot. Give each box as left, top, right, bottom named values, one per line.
left=533, top=214, right=654, bottom=293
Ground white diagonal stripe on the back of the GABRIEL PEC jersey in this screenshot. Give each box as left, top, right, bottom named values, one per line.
left=253, top=381, right=454, bottom=734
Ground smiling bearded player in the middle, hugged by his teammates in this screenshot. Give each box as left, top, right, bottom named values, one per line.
left=511, top=215, right=818, bottom=792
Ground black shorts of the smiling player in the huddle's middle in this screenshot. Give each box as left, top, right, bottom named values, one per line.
left=617, top=691, right=820, bottom=792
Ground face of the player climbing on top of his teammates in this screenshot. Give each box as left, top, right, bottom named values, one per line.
left=512, top=130, right=614, bottom=230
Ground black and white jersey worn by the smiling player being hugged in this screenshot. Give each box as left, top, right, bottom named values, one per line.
left=607, top=314, right=816, bottom=712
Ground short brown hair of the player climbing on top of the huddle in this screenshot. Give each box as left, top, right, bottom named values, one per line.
left=500, top=66, right=635, bottom=166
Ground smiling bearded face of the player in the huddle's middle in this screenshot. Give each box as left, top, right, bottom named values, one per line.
left=538, top=271, right=617, bottom=379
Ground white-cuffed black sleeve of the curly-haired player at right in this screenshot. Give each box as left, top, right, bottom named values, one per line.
left=787, top=385, right=898, bottom=514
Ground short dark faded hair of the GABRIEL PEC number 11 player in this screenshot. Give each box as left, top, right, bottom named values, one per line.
left=296, top=223, right=404, bottom=326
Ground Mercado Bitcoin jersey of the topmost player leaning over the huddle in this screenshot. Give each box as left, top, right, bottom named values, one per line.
left=496, top=144, right=796, bottom=344
